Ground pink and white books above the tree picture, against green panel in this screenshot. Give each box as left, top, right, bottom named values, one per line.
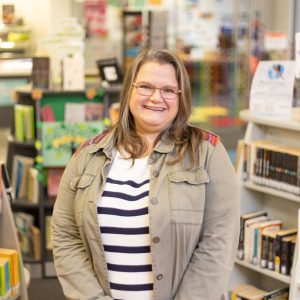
left=41, top=102, right=104, bottom=123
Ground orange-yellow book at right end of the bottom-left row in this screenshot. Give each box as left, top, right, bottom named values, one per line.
left=0, top=248, right=20, bottom=296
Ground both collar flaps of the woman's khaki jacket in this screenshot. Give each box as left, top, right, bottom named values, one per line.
left=89, top=128, right=174, bottom=157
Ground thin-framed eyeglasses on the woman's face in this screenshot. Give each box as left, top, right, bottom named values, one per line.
left=132, top=82, right=181, bottom=100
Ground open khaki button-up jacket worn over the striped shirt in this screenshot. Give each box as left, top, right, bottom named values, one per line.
left=52, top=132, right=239, bottom=300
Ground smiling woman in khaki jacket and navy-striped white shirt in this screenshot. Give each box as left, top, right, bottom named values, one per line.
left=52, top=50, right=239, bottom=300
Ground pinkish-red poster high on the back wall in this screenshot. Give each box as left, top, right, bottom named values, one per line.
left=84, top=0, right=107, bottom=35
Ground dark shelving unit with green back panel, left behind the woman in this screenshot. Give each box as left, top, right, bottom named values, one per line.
left=7, top=86, right=105, bottom=277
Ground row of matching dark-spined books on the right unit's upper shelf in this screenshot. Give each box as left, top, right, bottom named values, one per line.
left=243, top=140, right=300, bottom=195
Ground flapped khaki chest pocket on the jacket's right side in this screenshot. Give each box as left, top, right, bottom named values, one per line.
left=168, top=168, right=209, bottom=224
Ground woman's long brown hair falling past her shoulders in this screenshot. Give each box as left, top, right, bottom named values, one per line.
left=116, top=49, right=202, bottom=167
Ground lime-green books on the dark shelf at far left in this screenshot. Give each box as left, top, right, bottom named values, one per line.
left=14, top=104, right=35, bottom=142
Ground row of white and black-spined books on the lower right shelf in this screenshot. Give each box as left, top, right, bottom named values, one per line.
left=238, top=211, right=297, bottom=275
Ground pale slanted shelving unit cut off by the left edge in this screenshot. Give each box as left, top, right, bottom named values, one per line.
left=0, top=182, right=29, bottom=300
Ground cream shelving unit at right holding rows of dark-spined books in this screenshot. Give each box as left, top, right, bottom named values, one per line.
left=229, top=108, right=300, bottom=300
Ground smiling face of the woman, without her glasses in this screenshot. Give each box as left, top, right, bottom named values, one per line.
left=129, top=62, right=179, bottom=135
